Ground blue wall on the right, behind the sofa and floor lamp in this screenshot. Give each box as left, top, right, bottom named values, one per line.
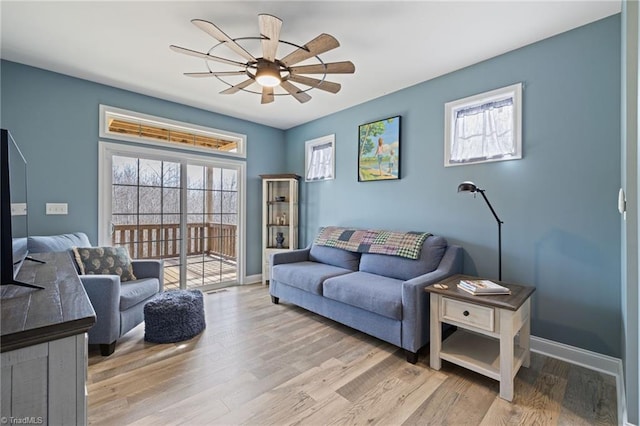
left=286, top=15, right=621, bottom=357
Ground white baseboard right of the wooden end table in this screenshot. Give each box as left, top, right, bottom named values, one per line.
left=531, top=336, right=633, bottom=426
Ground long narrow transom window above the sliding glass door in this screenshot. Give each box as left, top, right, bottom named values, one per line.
left=100, top=105, right=246, bottom=157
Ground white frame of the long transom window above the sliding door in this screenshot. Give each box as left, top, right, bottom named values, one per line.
left=99, top=105, right=247, bottom=158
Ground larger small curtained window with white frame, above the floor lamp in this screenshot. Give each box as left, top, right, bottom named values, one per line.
left=444, top=83, right=522, bottom=167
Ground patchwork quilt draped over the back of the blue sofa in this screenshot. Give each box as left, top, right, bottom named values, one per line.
left=314, top=226, right=431, bottom=259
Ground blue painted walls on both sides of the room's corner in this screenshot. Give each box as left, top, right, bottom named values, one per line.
left=0, top=15, right=621, bottom=357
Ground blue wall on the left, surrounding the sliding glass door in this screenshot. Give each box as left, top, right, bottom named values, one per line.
left=0, top=61, right=285, bottom=275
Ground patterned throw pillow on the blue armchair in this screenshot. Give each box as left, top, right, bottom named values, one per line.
left=73, top=247, right=136, bottom=281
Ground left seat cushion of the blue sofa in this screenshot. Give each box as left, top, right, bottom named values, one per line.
left=271, top=261, right=353, bottom=295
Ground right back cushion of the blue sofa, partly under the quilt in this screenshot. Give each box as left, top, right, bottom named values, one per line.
left=360, top=235, right=447, bottom=281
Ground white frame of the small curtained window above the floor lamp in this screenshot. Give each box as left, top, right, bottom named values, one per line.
left=444, top=83, right=523, bottom=167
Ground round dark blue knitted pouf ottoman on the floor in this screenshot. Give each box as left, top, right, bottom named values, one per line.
left=144, top=290, right=205, bottom=343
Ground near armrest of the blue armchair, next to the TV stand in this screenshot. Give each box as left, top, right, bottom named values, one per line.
left=80, top=275, right=120, bottom=344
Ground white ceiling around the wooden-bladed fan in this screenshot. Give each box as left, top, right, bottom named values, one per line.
left=0, top=0, right=621, bottom=129
